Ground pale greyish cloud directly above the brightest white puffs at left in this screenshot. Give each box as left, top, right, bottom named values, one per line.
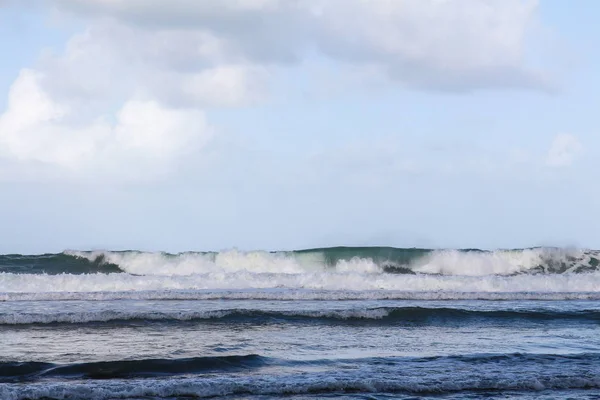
left=40, top=23, right=265, bottom=107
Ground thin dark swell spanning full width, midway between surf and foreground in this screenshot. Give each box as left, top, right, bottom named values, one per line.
left=0, top=307, right=600, bottom=326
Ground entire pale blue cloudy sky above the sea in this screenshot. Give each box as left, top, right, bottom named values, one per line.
left=0, top=0, right=600, bottom=253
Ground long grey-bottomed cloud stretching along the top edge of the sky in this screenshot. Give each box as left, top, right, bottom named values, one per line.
left=56, top=0, right=547, bottom=91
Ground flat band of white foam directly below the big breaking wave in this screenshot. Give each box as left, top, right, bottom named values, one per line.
left=0, top=271, right=600, bottom=296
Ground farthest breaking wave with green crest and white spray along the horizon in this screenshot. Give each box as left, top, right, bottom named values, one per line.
left=0, top=247, right=600, bottom=276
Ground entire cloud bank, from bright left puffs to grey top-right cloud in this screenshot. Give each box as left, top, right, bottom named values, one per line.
left=0, top=0, right=552, bottom=179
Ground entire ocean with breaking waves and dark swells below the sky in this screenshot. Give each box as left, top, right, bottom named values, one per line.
left=0, top=247, right=600, bottom=400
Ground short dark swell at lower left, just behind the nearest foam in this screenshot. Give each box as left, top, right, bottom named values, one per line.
left=0, top=354, right=267, bottom=383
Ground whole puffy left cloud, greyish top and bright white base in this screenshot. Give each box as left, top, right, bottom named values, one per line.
left=0, top=14, right=255, bottom=180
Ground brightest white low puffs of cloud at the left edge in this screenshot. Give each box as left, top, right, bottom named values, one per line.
left=0, top=70, right=211, bottom=179
